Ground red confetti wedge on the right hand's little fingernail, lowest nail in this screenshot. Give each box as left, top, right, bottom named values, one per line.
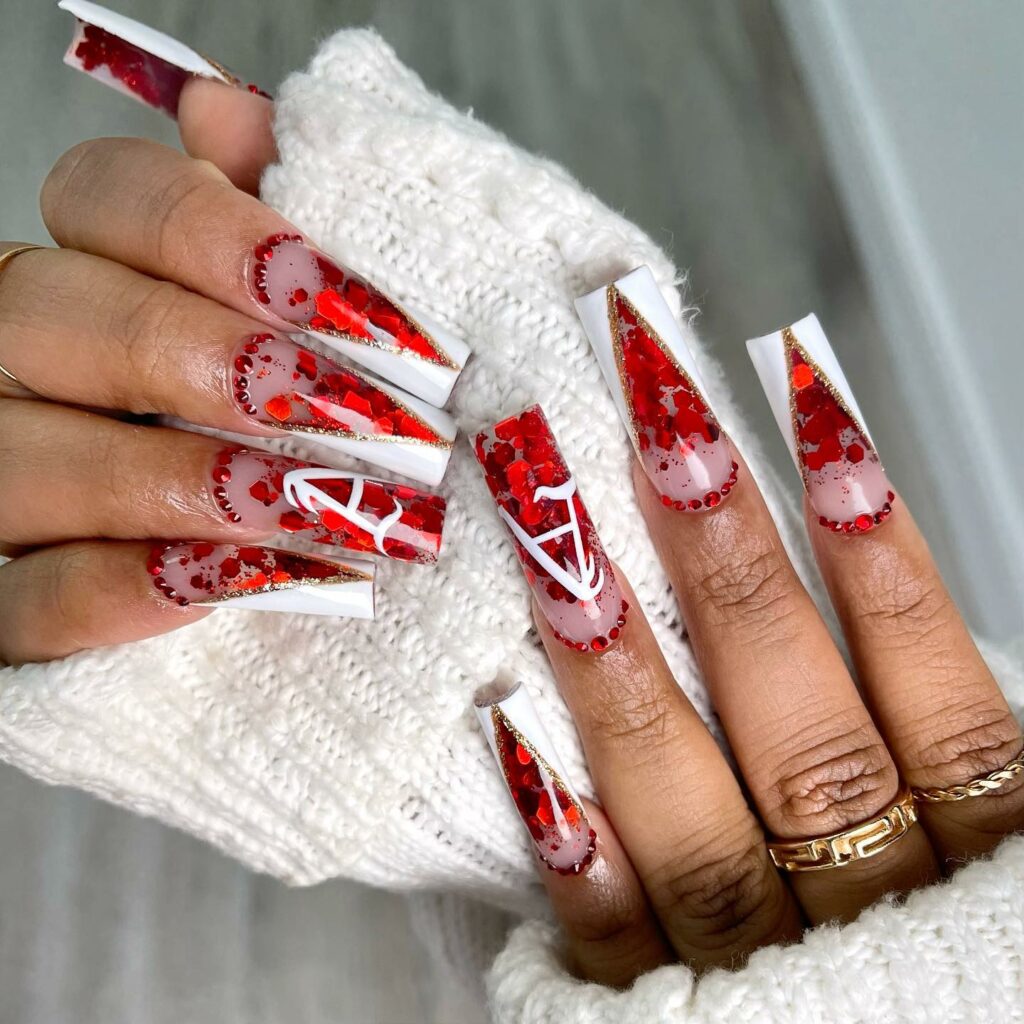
left=492, top=708, right=597, bottom=874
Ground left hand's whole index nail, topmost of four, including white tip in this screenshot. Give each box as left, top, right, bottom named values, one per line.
left=251, top=234, right=469, bottom=407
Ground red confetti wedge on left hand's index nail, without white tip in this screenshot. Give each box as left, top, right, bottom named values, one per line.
left=252, top=233, right=460, bottom=370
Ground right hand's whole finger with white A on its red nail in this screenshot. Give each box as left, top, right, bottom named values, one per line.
left=476, top=407, right=799, bottom=967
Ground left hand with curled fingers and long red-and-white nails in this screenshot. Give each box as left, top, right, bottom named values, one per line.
left=0, top=78, right=461, bottom=662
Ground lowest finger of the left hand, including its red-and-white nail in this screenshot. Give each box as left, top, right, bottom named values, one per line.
left=0, top=541, right=373, bottom=664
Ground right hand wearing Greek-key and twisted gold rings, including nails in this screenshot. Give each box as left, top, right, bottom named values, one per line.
left=476, top=288, right=1024, bottom=985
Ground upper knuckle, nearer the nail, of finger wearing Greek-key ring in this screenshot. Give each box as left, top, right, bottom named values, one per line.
left=696, top=546, right=794, bottom=621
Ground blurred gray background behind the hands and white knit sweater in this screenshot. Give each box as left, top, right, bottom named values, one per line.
left=0, top=0, right=1024, bottom=1024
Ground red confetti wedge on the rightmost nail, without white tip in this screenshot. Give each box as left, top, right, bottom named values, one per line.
left=782, top=328, right=895, bottom=534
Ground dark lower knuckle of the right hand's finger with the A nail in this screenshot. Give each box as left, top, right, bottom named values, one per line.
left=648, top=826, right=779, bottom=949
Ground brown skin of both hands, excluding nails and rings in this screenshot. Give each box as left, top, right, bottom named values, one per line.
left=0, top=74, right=1024, bottom=985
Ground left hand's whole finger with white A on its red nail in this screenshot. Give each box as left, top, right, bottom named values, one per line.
left=0, top=400, right=444, bottom=562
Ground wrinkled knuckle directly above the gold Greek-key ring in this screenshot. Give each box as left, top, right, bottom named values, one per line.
left=766, top=724, right=898, bottom=838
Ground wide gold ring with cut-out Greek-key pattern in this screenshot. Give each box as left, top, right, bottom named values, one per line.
left=768, top=783, right=918, bottom=871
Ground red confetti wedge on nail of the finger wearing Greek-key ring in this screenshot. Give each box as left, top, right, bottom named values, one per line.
left=607, top=287, right=737, bottom=512
